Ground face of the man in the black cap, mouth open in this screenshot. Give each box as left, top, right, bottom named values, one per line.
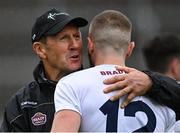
left=45, top=25, right=82, bottom=73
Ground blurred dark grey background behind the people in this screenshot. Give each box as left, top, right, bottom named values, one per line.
left=0, top=0, right=180, bottom=123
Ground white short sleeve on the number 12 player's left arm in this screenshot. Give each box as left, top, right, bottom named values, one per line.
left=54, top=80, right=81, bottom=115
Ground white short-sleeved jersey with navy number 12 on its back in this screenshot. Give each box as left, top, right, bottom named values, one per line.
left=55, top=65, right=175, bottom=132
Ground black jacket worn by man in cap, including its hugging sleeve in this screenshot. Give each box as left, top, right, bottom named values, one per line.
left=0, top=63, right=180, bottom=132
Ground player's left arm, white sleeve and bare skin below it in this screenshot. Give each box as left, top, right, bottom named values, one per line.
left=51, top=78, right=81, bottom=132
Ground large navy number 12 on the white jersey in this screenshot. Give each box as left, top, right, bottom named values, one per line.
left=100, top=100, right=156, bottom=132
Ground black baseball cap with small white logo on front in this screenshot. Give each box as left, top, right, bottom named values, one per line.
left=31, top=8, right=88, bottom=43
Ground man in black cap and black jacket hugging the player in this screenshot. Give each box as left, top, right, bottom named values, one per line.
left=1, top=9, right=179, bottom=132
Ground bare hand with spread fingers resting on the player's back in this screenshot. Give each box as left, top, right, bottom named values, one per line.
left=104, top=66, right=152, bottom=108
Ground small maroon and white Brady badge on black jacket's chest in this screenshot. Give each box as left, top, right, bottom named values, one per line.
left=31, top=112, right=46, bottom=126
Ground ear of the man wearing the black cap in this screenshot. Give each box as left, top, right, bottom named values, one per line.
left=33, top=42, right=46, bottom=59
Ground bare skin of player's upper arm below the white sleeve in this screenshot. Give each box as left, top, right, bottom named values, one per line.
left=51, top=110, right=81, bottom=132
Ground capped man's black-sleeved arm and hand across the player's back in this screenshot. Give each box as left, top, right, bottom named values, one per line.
left=104, top=67, right=180, bottom=113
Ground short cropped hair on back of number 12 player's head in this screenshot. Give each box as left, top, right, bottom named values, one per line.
left=89, top=10, right=132, bottom=53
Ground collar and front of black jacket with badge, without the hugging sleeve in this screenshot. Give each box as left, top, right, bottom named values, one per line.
left=1, top=62, right=56, bottom=132
